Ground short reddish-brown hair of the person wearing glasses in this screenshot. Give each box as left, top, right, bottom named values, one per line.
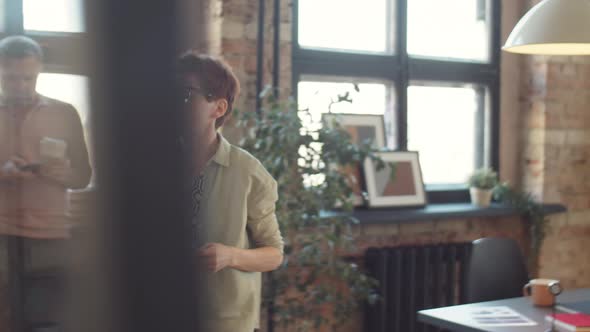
left=177, top=51, right=240, bottom=128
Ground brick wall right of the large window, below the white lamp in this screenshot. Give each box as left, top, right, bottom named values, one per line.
left=521, top=56, right=590, bottom=288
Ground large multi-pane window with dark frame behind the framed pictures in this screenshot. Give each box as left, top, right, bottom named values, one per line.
left=292, top=0, right=500, bottom=203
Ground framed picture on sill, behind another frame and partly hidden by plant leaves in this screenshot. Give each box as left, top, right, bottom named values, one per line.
left=322, top=113, right=385, bottom=206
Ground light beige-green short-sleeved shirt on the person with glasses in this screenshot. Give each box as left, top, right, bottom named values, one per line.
left=198, top=135, right=283, bottom=332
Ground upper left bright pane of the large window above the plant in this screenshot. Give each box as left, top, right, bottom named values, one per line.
left=298, top=0, right=393, bottom=53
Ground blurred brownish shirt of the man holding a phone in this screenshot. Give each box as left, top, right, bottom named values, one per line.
left=0, top=96, right=91, bottom=238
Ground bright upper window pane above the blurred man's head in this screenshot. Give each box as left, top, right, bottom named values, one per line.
left=23, top=0, right=85, bottom=32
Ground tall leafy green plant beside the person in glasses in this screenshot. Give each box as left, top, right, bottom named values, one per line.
left=238, top=91, right=385, bottom=331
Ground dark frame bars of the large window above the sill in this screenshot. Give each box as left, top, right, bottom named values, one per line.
left=291, top=0, right=501, bottom=203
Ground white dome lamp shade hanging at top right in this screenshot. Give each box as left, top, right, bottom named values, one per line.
left=502, top=0, right=590, bottom=55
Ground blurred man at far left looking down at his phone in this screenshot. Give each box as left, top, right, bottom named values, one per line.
left=0, top=36, right=91, bottom=330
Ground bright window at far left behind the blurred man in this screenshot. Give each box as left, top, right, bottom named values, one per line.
left=0, top=0, right=89, bottom=134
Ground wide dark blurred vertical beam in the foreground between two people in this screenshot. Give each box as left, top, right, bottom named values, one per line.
left=85, top=0, right=198, bottom=332
